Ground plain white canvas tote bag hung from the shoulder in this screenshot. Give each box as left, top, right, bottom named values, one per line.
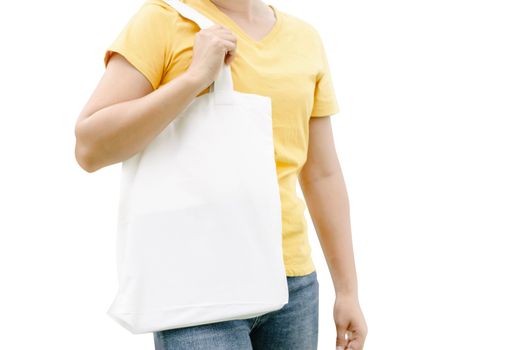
left=107, top=0, right=288, bottom=334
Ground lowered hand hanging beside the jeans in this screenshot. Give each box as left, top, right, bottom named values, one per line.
left=334, top=293, right=368, bottom=350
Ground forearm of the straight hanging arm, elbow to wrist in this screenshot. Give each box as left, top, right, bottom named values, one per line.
left=301, top=171, right=357, bottom=297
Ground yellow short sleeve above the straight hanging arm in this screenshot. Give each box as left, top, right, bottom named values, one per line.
left=311, top=30, right=339, bottom=117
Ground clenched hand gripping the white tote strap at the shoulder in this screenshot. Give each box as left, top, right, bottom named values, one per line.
left=188, top=24, right=237, bottom=86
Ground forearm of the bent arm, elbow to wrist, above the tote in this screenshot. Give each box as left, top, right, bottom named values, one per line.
left=76, top=71, right=206, bottom=172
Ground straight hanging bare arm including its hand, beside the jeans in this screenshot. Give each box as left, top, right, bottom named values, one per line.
left=299, top=116, right=367, bottom=349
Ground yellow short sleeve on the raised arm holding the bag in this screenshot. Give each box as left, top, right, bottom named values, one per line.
left=104, top=1, right=173, bottom=89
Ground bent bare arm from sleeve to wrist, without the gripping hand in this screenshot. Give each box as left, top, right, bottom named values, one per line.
left=75, top=53, right=208, bottom=172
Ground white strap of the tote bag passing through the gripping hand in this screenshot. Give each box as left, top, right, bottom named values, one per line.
left=164, top=0, right=233, bottom=102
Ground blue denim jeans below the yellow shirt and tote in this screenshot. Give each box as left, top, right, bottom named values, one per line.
left=153, top=271, right=319, bottom=350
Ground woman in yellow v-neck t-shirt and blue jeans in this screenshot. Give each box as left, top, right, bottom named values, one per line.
left=75, top=0, right=367, bottom=350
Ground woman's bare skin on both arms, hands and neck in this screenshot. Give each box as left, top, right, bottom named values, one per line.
left=75, top=0, right=368, bottom=350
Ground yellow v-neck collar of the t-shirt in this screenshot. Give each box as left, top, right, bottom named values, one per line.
left=183, top=0, right=282, bottom=47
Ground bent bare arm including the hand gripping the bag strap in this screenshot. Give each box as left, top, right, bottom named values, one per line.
left=75, top=24, right=237, bottom=172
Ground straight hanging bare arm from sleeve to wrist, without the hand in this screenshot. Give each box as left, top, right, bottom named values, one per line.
left=299, top=116, right=357, bottom=296
